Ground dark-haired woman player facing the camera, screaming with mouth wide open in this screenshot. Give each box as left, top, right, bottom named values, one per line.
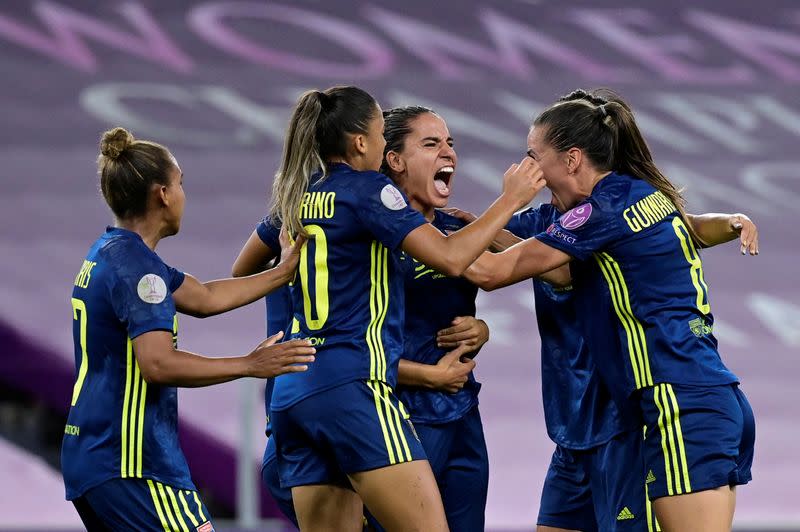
left=233, top=107, right=489, bottom=531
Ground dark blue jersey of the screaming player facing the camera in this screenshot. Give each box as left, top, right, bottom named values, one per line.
left=397, top=211, right=481, bottom=424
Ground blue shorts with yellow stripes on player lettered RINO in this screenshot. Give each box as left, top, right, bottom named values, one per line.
left=272, top=381, right=426, bottom=488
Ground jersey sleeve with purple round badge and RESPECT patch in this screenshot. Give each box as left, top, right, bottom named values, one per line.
left=536, top=197, right=623, bottom=260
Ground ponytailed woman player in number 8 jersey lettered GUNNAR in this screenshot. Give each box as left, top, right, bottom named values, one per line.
left=468, top=91, right=758, bottom=531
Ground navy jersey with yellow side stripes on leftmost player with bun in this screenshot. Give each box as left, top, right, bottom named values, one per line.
left=61, top=227, right=195, bottom=500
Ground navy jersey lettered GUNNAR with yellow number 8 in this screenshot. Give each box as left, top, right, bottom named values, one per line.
left=536, top=173, right=738, bottom=400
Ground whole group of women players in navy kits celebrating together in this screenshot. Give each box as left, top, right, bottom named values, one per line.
left=62, top=86, right=758, bottom=532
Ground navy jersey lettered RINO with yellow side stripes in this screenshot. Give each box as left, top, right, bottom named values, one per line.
left=271, top=164, right=427, bottom=410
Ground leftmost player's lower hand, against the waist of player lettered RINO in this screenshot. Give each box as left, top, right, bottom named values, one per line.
left=247, top=332, right=317, bottom=379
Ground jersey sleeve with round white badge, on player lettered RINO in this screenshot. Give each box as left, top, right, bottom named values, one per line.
left=354, top=172, right=428, bottom=249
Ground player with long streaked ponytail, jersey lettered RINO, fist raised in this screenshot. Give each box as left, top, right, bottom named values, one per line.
left=271, top=87, right=543, bottom=531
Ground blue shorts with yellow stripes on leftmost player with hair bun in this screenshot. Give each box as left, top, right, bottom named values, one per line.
left=72, top=478, right=214, bottom=532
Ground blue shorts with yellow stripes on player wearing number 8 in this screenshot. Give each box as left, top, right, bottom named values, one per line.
left=640, top=384, right=756, bottom=499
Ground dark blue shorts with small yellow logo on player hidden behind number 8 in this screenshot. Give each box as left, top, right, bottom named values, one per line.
left=536, top=430, right=658, bottom=532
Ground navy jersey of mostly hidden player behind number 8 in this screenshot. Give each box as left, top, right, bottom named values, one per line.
left=506, top=204, right=637, bottom=450
